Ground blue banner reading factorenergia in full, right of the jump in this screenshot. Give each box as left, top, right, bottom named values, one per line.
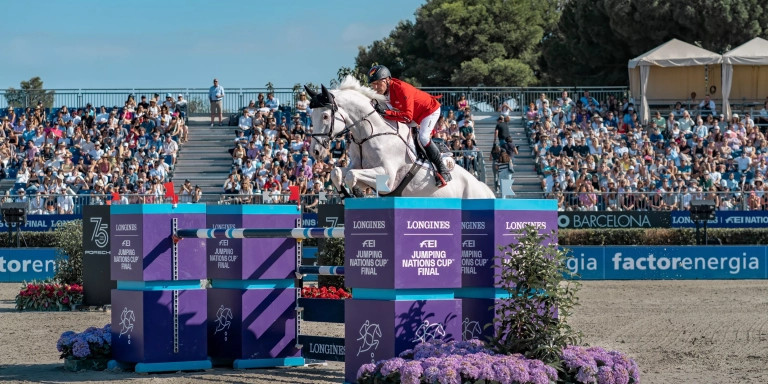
left=564, top=246, right=768, bottom=280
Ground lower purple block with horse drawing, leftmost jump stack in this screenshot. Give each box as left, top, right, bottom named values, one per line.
left=112, top=289, right=208, bottom=363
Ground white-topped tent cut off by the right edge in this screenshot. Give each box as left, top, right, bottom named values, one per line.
left=722, top=37, right=768, bottom=116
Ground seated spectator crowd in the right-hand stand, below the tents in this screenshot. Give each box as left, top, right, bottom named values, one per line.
left=524, top=91, right=768, bottom=211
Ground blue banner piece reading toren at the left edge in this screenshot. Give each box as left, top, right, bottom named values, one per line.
left=0, top=248, right=62, bottom=283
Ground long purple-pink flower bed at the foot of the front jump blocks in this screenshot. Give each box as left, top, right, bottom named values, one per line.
left=357, top=340, right=639, bottom=384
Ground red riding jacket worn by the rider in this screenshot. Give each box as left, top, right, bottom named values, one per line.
left=384, top=77, right=440, bottom=123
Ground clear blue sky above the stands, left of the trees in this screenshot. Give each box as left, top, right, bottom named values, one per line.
left=0, top=0, right=424, bottom=89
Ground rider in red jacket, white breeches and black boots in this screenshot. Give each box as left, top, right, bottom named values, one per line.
left=368, top=65, right=451, bottom=188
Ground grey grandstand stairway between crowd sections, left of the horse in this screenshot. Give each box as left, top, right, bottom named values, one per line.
left=173, top=117, right=235, bottom=201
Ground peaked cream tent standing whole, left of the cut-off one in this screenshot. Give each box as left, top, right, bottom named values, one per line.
left=628, top=39, right=723, bottom=121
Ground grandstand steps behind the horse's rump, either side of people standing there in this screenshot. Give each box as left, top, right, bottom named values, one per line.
left=472, top=112, right=544, bottom=199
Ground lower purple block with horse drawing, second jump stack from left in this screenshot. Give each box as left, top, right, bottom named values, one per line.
left=208, top=288, right=301, bottom=360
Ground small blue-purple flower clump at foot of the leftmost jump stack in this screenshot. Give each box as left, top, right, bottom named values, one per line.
left=56, top=324, right=112, bottom=371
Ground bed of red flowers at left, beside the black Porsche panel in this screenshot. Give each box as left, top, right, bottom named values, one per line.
left=16, top=281, right=83, bottom=311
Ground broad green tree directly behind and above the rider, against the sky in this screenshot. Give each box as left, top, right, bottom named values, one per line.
left=355, top=0, right=563, bottom=86
